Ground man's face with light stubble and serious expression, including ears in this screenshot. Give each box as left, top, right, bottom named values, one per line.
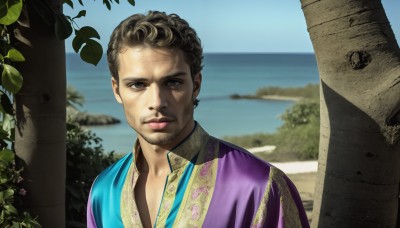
left=112, top=46, right=201, bottom=149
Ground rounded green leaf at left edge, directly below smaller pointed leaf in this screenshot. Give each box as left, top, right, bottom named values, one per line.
left=1, top=64, right=23, bottom=94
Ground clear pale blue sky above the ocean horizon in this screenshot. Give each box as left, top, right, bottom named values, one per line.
left=64, top=0, right=400, bottom=53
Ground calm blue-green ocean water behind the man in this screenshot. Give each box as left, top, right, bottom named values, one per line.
left=67, top=53, right=319, bottom=153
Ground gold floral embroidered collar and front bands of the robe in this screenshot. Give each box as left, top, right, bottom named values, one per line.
left=121, top=125, right=219, bottom=227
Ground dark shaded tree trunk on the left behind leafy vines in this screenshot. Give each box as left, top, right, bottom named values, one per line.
left=14, top=0, right=66, bottom=227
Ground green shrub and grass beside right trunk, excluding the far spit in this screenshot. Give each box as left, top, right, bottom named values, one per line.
left=224, top=100, right=320, bottom=161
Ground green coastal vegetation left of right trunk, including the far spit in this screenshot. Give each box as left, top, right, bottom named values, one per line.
left=224, top=84, right=319, bottom=161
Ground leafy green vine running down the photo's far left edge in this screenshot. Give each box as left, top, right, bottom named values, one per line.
left=0, top=0, right=40, bottom=227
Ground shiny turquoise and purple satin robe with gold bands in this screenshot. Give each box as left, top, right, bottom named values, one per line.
left=87, top=124, right=309, bottom=228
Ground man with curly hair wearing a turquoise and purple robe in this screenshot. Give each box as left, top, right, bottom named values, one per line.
left=87, top=12, right=309, bottom=227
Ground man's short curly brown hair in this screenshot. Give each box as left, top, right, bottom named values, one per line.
left=107, top=11, right=203, bottom=81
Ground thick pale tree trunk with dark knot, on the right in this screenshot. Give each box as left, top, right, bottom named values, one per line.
left=301, top=0, right=400, bottom=228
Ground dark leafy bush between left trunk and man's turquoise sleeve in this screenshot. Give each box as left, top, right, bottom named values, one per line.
left=66, top=124, right=118, bottom=227
